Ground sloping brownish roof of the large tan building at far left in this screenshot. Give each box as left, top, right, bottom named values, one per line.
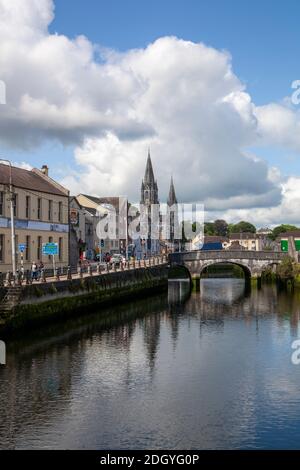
left=0, top=163, right=67, bottom=197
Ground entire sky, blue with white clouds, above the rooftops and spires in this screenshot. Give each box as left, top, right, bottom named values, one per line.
left=0, top=0, right=300, bottom=225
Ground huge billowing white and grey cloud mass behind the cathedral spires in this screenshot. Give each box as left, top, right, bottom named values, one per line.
left=0, top=0, right=300, bottom=222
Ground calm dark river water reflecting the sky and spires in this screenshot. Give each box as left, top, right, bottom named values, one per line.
left=0, top=279, right=300, bottom=449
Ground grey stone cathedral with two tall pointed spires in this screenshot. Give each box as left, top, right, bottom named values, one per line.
left=140, top=150, right=178, bottom=256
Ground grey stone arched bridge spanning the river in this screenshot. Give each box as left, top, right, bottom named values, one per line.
left=169, top=250, right=286, bottom=277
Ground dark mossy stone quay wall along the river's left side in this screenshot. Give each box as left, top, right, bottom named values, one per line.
left=0, top=264, right=168, bottom=336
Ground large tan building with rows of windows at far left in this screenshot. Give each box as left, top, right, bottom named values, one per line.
left=0, top=164, right=69, bottom=272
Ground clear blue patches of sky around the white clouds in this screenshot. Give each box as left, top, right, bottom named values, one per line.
left=6, top=0, right=300, bottom=176
